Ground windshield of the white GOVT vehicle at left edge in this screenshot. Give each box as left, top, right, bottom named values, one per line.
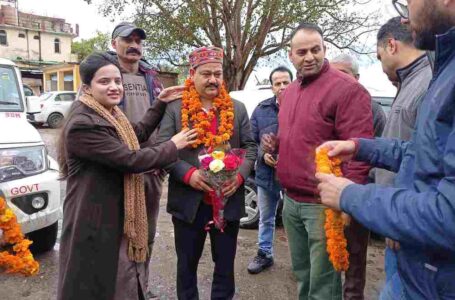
left=0, top=66, right=23, bottom=112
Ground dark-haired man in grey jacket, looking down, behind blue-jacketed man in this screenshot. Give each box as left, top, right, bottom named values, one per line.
left=376, top=17, right=433, bottom=299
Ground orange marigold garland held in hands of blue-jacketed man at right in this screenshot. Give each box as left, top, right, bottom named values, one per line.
left=316, top=149, right=349, bottom=272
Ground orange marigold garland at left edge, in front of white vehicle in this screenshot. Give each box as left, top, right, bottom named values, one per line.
left=0, top=197, right=39, bottom=276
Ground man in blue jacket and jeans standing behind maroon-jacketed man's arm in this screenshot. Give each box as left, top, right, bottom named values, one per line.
left=248, top=67, right=293, bottom=274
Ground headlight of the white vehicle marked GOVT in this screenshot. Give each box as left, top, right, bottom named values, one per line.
left=0, top=146, right=48, bottom=182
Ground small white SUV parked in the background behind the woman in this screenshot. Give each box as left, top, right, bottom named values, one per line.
left=28, top=91, right=76, bottom=128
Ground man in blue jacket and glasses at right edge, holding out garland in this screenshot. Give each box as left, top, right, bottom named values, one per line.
left=317, top=0, right=455, bottom=299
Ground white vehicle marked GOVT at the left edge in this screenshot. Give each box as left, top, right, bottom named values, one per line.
left=0, top=58, right=61, bottom=253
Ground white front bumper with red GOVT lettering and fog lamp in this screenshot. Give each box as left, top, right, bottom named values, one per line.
left=0, top=170, right=61, bottom=233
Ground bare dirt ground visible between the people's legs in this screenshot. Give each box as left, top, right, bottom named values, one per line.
left=150, top=183, right=384, bottom=300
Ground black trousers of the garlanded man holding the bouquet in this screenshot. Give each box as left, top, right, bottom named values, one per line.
left=172, top=203, right=239, bottom=300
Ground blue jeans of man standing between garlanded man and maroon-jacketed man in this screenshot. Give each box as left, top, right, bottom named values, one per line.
left=258, top=186, right=280, bottom=257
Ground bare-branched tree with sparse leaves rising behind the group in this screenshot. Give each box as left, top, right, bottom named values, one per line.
left=84, top=0, right=378, bottom=89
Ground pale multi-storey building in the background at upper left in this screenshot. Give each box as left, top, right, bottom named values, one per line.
left=0, top=0, right=178, bottom=95
